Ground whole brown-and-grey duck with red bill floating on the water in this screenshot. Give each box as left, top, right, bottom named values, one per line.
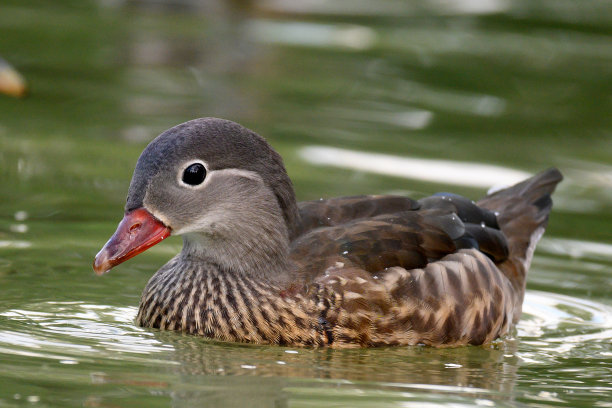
left=94, top=118, right=562, bottom=347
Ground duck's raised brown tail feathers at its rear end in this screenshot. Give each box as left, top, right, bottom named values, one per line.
left=478, top=168, right=563, bottom=310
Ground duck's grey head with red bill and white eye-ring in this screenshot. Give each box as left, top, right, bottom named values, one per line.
left=94, top=118, right=298, bottom=274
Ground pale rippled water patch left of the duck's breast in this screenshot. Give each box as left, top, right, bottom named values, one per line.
left=0, top=302, right=172, bottom=362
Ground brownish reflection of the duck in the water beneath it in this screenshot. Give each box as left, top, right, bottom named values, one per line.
left=151, top=332, right=518, bottom=407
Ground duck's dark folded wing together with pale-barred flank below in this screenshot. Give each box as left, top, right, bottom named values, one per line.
left=291, top=199, right=515, bottom=347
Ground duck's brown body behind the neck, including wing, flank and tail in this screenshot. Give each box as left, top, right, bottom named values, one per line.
left=291, top=169, right=562, bottom=346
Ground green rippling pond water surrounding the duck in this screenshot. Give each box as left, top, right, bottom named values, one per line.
left=0, top=0, right=612, bottom=407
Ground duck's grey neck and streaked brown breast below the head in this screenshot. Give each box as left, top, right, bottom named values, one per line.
left=137, top=185, right=325, bottom=345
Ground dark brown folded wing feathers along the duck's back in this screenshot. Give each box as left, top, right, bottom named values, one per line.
left=291, top=194, right=508, bottom=275
